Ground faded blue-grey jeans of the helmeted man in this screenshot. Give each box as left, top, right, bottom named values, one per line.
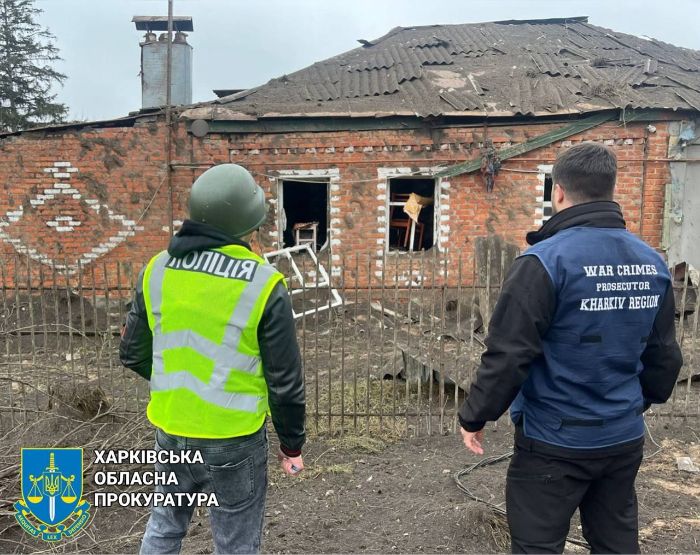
left=141, top=426, right=267, bottom=554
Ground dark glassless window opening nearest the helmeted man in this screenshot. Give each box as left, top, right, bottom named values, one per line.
left=279, top=180, right=328, bottom=251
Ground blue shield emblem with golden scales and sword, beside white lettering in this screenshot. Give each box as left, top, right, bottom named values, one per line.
left=14, top=448, right=90, bottom=542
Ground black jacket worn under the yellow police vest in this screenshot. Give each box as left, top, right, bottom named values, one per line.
left=119, top=220, right=306, bottom=456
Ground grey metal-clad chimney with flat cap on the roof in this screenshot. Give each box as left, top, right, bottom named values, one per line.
left=132, top=16, right=194, bottom=109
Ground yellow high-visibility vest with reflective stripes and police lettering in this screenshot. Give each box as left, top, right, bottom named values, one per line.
left=143, top=245, right=284, bottom=438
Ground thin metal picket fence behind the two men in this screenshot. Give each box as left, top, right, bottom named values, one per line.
left=0, top=248, right=700, bottom=436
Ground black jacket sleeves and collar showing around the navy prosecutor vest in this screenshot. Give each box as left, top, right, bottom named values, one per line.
left=459, top=201, right=683, bottom=440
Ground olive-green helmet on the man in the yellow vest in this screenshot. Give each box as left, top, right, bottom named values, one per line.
left=190, top=164, right=267, bottom=237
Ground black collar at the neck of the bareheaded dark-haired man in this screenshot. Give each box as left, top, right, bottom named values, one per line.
left=525, top=200, right=625, bottom=245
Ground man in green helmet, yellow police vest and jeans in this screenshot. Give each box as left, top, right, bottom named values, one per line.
left=119, top=164, right=305, bottom=553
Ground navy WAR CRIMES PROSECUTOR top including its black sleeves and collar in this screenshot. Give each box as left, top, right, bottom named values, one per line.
left=460, top=202, right=682, bottom=449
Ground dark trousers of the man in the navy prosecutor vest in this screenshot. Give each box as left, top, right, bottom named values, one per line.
left=506, top=430, right=644, bottom=553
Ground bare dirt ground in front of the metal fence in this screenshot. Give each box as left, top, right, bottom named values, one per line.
left=0, top=419, right=700, bottom=553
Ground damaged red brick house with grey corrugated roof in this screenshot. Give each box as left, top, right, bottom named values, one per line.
left=0, top=18, right=700, bottom=284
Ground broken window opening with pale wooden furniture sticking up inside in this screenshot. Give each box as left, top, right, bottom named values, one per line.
left=387, top=178, right=436, bottom=251
